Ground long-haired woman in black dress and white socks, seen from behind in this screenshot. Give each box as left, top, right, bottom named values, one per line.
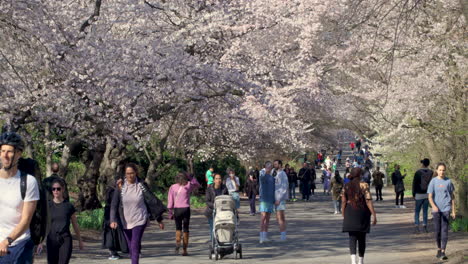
left=341, top=168, right=377, bottom=264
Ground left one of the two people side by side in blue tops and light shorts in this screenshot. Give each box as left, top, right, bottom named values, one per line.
left=259, top=161, right=275, bottom=243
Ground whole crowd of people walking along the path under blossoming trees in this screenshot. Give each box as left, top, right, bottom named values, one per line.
left=0, top=132, right=456, bottom=264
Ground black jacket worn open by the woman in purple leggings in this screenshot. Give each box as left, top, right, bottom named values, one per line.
left=110, top=181, right=167, bottom=225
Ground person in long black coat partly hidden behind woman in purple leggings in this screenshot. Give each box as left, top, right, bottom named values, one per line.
left=102, top=178, right=128, bottom=260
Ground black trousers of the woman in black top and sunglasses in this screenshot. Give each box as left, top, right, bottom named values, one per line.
left=46, top=234, right=73, bottom=264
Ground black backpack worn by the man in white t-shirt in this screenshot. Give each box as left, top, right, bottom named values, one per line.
left=18, top=158, right=50, bottom=245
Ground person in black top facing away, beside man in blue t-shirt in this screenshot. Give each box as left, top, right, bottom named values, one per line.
left=412, top=158, right=434, bottom=233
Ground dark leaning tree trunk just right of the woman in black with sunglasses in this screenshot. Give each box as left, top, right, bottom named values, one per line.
left=76, top=145, right=104, bottom=211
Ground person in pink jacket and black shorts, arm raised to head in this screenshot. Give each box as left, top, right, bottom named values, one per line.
left=167, top=172, right=200, bottom=256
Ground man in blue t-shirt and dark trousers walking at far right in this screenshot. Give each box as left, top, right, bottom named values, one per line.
left=427, top=163, right=456, bottom=260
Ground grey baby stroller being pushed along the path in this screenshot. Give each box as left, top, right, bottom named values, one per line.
left=210, top=195, right=242, bottom=260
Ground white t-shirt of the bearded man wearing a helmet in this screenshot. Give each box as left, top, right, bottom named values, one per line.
left=0, top=170, right=39, bottom=245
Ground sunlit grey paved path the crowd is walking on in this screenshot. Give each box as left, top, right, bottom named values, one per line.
left=36, top=185, right=468, bottom=264
